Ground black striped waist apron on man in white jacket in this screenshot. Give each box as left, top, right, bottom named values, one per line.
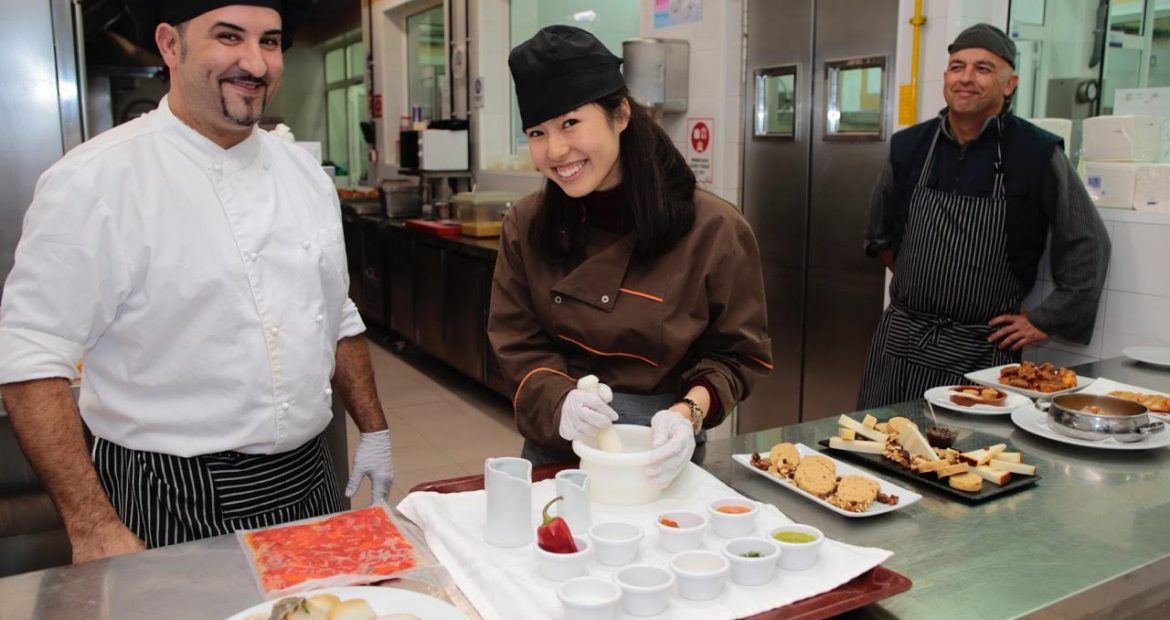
left=94, top=435, right=342, bottom=547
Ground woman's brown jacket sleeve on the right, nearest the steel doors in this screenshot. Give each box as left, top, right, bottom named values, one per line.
left=682, top=219, right=772, bottom=428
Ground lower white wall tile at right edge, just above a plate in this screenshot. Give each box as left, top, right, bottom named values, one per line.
left=1101, top=290, right=1170, bottom=358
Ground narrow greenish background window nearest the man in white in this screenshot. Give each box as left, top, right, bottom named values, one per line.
left=325, top=32, right=369, bottom=185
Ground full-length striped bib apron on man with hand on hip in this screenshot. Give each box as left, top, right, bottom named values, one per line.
left=858, top=119, right=1027, bottom=409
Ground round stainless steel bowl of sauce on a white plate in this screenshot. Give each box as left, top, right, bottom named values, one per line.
left=1047, top=394, right=1165, bottom=443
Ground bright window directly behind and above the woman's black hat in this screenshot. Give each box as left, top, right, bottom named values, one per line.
left=508, top=0, right=641, bottom=157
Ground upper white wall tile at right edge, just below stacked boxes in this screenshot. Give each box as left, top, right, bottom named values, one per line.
left=1106, top=222, right=1170, bottom=297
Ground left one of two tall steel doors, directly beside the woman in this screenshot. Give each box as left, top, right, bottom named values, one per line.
left=737, top=0, right=815, bottom=433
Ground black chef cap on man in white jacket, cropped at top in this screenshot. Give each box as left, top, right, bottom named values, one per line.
left=126, top=0, right=316, bottom=53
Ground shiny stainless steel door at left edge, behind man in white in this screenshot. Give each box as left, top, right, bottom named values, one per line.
left=0, top=0, right=81, bottom=295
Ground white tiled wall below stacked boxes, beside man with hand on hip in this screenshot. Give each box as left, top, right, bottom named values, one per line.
left=1025, top=209, right=1170, bottom=366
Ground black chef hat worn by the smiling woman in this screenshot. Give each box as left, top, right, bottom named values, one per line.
left=508, top=26, right=626, bottom=129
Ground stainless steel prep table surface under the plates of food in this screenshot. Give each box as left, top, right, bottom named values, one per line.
left=0, top=360, right=1170, bottom=620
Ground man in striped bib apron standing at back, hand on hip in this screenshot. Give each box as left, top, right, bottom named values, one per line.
left=858, top=23, right=1109, bottom=408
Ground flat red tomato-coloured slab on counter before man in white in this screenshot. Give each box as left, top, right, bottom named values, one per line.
left=241, top=505, right=415, bottom=594
